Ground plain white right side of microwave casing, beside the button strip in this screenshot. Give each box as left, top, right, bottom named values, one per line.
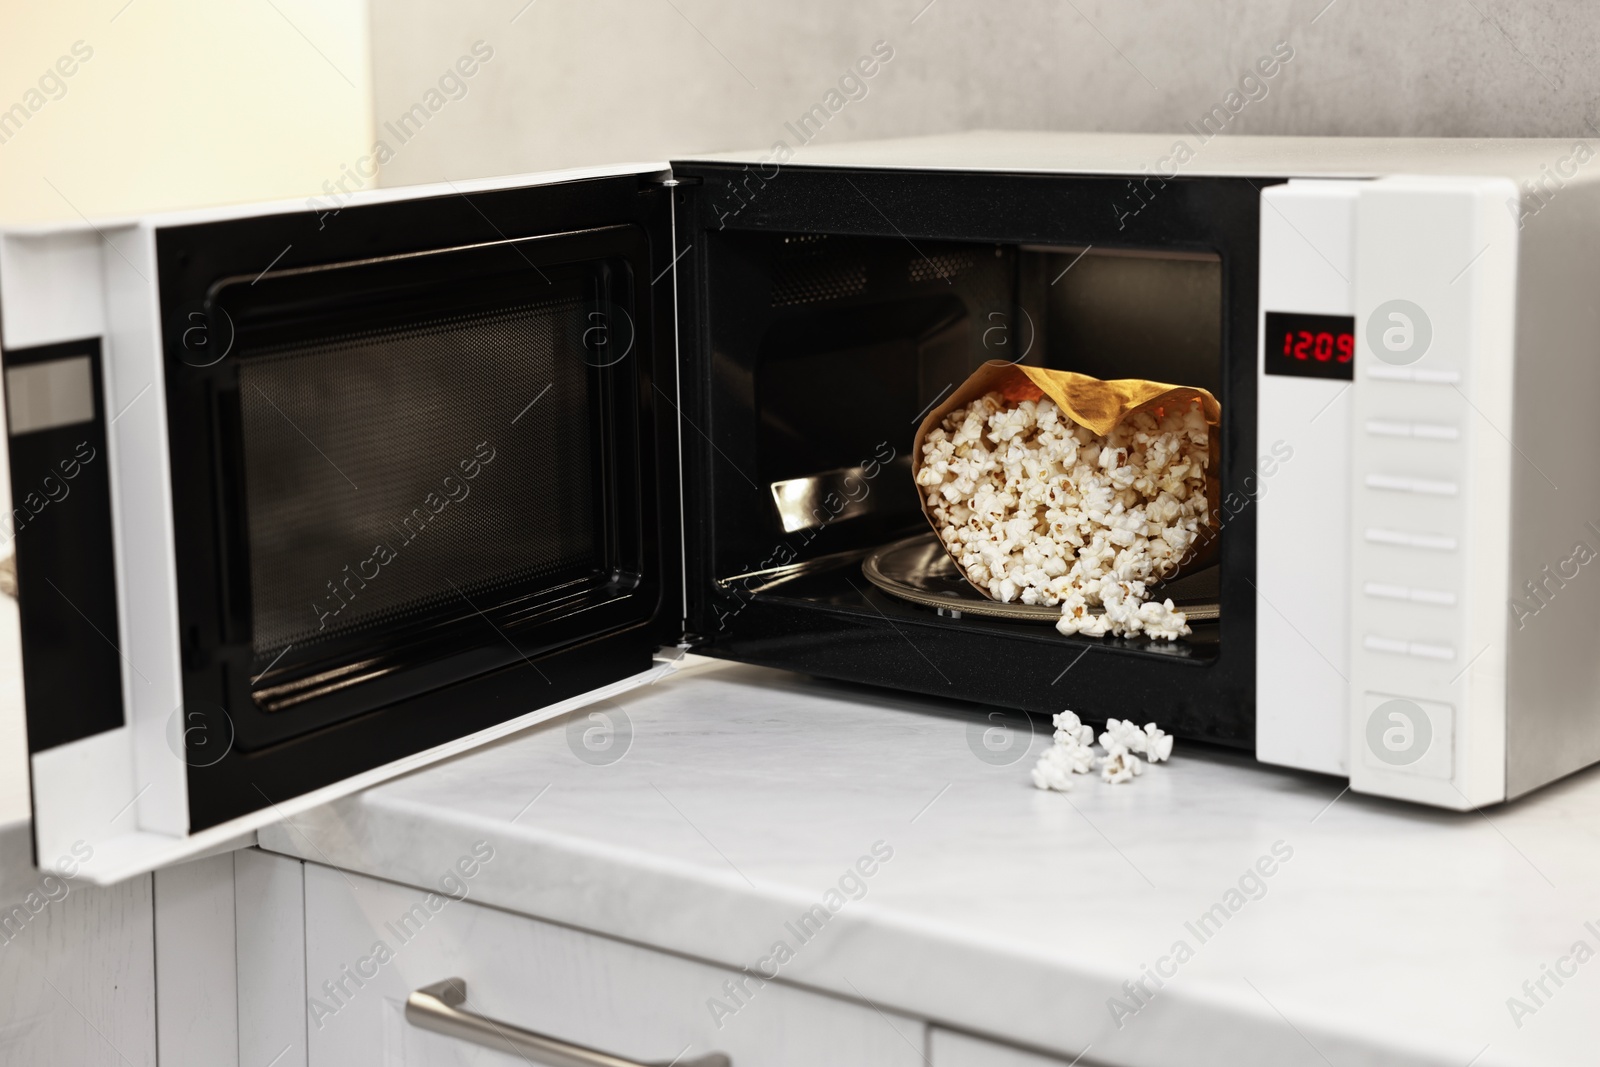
left=1501, top=168, right=1600, bottom=798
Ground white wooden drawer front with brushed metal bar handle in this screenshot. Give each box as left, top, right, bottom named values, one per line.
left=306, top=857, right=926, bottom=1067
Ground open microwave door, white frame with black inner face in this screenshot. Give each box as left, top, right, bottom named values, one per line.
left=0, top=165, right=683, bottom=883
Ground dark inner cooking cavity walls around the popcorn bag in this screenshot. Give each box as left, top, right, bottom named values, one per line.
left=691, top=234, right=1226, bottom=627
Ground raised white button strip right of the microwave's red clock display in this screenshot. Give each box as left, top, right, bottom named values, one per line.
left=1347, top=178, right=1517, bottom=808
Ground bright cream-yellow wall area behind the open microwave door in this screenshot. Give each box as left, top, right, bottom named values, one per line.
left=0, top=0, right=373, bottom=822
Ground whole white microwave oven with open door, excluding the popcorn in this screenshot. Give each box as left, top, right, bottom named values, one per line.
left=0, top=133, right=1600, bottom=880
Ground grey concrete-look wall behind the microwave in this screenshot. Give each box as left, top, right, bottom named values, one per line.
left=373, top=0, right=1600, bottom=184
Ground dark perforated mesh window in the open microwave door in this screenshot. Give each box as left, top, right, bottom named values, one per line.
left=238, top=299, right=603, bottom=657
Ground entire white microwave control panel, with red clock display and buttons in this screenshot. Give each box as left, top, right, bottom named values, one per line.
left=1253, top=178, right=1517, bottom=808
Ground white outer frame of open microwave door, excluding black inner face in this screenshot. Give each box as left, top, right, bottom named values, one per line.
left=0, top=165, right=682, bottom=885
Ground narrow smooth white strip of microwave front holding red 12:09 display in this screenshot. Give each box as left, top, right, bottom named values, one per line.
left=1245, top=181, right=1366, bottom=774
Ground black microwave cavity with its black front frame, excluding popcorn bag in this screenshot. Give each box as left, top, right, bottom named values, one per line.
left=680, top=166, right=1259, bottom=747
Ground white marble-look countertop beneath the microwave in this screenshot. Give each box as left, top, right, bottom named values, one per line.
left=261, top=661, right=1600, bottom=1067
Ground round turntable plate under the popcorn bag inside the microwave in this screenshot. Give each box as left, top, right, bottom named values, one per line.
left=861, top=530, right=1222, bottom=624
